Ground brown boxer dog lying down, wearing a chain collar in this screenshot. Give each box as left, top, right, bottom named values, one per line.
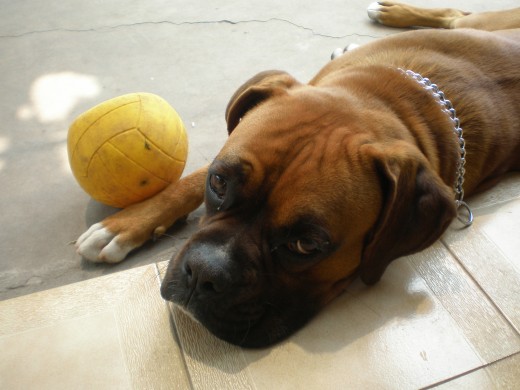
left=78, top=3, right=520, bottom=346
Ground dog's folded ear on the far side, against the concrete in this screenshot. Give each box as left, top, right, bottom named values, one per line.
left=226, top=70, right=299, bottom=134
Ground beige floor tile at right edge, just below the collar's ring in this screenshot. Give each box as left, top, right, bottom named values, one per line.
left=443, top=199, right=520, bottom=331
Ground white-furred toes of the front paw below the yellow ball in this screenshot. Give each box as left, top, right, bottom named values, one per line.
left=76, top=222, right=135, bottom=263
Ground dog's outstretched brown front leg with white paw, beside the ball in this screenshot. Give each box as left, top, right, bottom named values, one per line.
left=76, top=166, right=208, bottom=263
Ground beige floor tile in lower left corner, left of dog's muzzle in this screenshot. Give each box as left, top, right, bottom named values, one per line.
left=0, top=265, right=189, bottom=389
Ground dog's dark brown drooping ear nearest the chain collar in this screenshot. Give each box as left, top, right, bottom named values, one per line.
left=359, top=143, right=456, bottom=284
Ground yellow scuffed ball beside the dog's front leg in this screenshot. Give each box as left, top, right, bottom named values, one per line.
left=67, top=93, right=188, bottom=208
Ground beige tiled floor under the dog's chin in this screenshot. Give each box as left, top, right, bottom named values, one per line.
left=0, top=175, right=520, bottom=389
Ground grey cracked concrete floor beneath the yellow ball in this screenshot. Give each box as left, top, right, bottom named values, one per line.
left=0, top=0, right=518, bottom=300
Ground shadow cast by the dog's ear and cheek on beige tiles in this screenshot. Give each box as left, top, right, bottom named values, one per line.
left=289, top=259, right=434, bottom=354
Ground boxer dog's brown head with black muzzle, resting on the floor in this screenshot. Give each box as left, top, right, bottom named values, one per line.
left=162, top=72, right=454, bottom=347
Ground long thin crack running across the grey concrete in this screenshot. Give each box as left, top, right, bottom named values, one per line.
left=0, top=18, right=379, bottom=39
